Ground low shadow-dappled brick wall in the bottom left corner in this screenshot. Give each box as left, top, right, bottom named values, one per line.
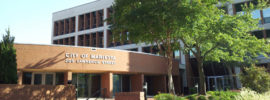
left=0, top=84, right=76, bottom=100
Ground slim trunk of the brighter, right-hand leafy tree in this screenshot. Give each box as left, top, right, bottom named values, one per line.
left=197, top=58, right=206, bottom=95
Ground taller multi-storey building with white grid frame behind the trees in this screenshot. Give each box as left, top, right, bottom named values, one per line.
left=51, top=0, right=270, bottom=97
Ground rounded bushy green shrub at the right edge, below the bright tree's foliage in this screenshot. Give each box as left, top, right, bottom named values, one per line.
left=240, top=66, right=270, bottom=93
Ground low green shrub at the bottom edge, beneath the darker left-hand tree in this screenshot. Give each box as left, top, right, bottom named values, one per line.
left=154, top=93, right=185, bottom=100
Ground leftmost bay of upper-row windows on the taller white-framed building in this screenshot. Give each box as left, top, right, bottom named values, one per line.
left=54, top=17, right=76, bottom=36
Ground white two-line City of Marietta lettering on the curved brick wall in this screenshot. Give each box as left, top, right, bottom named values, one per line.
left=65, top=53, right=116, bottom=65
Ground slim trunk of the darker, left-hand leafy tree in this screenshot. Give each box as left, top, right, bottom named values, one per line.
left=167, top=47, right=175, bottom=94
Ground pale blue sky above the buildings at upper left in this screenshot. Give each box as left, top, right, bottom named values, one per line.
left=0, top=0, right=95, bottom=44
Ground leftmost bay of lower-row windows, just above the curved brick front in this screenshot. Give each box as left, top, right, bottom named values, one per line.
left=53, top=37, right=75, bottom=45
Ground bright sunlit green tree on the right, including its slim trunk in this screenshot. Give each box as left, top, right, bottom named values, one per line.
left=178, top=0, right=269, bottom=95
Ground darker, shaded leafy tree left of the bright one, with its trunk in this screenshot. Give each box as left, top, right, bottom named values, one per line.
left=109, top=0, right=185, bottom=94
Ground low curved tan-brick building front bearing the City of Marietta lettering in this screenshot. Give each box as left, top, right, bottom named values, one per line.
left=14, top=44, right=181, bottom=98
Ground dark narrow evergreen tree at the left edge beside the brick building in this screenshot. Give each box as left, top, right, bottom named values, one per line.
left=0, top=29, right=17, bottom=84
